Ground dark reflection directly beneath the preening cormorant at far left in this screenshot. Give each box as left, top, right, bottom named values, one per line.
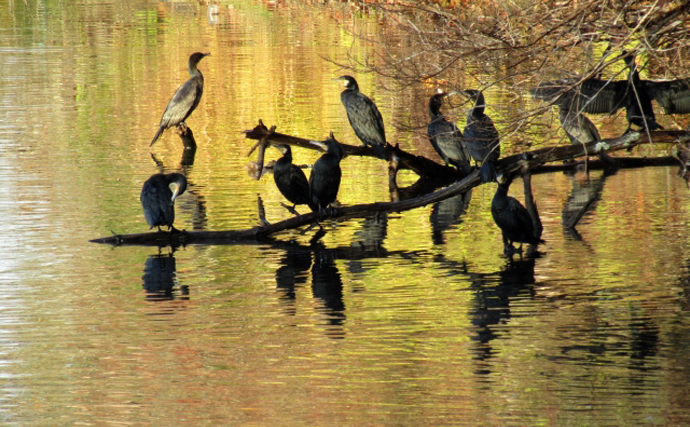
left=142, top=253, right=189, bottom=301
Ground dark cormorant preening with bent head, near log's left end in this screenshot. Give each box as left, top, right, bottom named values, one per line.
left=139, top=173, right=187, bottom=231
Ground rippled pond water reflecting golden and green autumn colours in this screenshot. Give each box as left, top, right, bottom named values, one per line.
left=0, top=1, right=690, bottom=426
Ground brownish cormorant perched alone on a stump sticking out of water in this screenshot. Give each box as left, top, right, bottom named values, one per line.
left=150, top=52, right=210, bottom=146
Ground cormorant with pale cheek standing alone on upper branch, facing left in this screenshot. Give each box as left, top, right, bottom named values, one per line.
left=335, top=76, right=388, bottom=160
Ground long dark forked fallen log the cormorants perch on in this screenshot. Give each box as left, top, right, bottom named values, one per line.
left=91, top=126, right=688, bottom=246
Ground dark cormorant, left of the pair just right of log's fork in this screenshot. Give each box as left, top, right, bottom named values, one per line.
left=427, top=91, right=471, bottom=175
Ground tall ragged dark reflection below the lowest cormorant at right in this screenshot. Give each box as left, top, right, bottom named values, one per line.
left=470, top=257, right=535, bottom=375
